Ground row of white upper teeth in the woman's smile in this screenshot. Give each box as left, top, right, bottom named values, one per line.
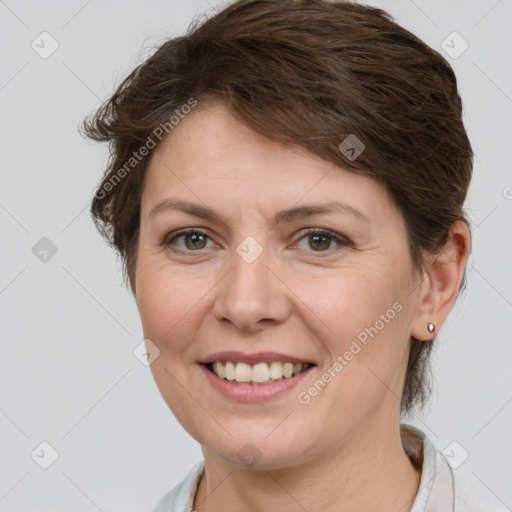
left=212, top=361, right=310, bottom=384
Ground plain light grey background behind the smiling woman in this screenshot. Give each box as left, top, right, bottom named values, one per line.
left=0, top=0, right=512, bottom=512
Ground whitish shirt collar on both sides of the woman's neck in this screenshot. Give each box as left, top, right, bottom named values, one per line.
left=153, top=424, right=510, bottom=512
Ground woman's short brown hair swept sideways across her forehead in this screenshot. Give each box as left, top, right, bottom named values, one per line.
left=83, top=0, right=473, bottom=413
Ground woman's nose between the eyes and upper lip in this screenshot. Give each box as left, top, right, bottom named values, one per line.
left=214, top=246, right=290, bottom=332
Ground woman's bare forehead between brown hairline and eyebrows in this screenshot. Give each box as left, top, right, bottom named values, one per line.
left=143, top=105, right=394, bottom=224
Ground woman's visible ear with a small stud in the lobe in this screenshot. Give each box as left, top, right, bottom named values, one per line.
left=411, top=221, right=471, bottom=341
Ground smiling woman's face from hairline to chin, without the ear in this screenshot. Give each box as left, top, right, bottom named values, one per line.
left=136, top=106, right=421, bottom=468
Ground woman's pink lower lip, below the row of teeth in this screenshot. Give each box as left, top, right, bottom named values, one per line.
left=199, top=364, right=315, bottom=402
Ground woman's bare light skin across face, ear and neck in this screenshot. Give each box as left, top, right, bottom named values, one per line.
left=136, top=105, right=470, bottom=512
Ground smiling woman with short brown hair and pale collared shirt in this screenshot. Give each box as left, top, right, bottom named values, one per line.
left=84, top=0, right=504, bottom=512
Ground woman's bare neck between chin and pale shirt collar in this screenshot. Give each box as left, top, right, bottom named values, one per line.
left=194, top=428, right=421, bottom=512
